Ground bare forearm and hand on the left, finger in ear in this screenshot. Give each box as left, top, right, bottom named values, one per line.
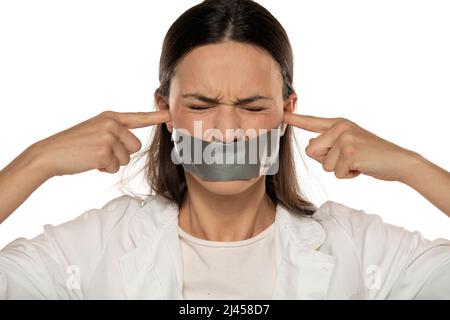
left=0, top=110, right=170, bottom=223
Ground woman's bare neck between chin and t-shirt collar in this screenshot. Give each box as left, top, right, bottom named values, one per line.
left=179, top=175, right=275, bottom=241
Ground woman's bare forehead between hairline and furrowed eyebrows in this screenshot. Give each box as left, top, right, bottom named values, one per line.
left=172, top=42, right=282, bottom=96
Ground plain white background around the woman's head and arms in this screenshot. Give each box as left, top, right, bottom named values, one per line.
left=0, top=0, right=450, bottom=247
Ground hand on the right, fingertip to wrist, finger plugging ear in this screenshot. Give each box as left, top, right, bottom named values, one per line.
left=284, top=113, right=415, bottom=181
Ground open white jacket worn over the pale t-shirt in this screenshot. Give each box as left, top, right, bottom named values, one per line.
left=0, top=196, right=450, bottom=299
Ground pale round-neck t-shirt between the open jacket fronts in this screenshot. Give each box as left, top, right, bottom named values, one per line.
left=178, top=224, right=276, bottom=300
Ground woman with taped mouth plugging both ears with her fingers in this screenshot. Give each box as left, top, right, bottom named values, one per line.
left=0, top=0, right=450, bottom=299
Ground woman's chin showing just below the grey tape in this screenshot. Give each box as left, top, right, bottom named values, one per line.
left=186, top=173, right=263, bottom=196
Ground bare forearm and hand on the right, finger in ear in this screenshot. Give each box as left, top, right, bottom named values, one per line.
left=284, top=113, right=450, bottom=217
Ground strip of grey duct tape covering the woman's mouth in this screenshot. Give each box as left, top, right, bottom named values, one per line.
left=172, top=123, right=282, bottom=181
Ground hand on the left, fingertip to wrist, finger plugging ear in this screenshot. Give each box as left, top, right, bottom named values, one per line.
left=32, top=110, right=170, bottom=178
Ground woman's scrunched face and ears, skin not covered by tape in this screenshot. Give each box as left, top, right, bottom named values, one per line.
left=157, top=42, right=296, bottom=195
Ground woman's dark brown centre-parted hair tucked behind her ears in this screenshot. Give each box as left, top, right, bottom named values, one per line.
left=121, top=0, right=316, bottom=215
